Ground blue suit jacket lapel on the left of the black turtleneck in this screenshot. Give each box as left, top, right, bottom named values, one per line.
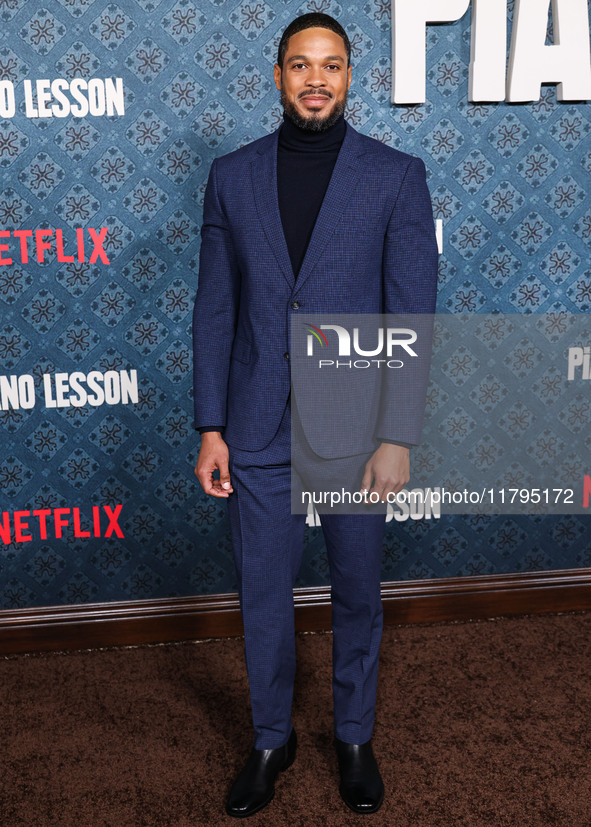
left=251, top=130, right=295, bottom=289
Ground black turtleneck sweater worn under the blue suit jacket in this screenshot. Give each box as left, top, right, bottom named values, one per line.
left=277, top=114, right=346, bottom=279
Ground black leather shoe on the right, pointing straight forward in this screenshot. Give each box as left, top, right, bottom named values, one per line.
left=335, top=738, right=384, bottom=813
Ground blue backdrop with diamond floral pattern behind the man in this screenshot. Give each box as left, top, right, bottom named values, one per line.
left=0, top=0, right=591, bottom=608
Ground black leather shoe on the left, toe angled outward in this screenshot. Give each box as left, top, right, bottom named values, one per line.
left=226, top=729, right=298, bottom=818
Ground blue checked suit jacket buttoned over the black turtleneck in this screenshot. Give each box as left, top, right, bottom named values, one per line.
left=193, top=124, right=437, bottom=457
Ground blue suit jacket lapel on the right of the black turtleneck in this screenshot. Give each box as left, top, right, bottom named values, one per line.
left=296, top=124, right=364, bottom=289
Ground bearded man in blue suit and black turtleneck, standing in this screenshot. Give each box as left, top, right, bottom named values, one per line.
left=193, top=13, right=437, bottom=817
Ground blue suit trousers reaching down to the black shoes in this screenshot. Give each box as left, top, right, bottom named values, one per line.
left=228, top=394, right=385, bottom=749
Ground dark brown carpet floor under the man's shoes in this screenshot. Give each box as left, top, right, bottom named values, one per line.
left=0, top=613, right=591, bottom=827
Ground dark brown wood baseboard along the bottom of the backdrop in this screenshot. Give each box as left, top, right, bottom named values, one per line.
left=0, top=568, right=591, bottom=654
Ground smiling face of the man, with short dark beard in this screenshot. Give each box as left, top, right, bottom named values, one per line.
left=274, top=28, right=351, bottom=132
